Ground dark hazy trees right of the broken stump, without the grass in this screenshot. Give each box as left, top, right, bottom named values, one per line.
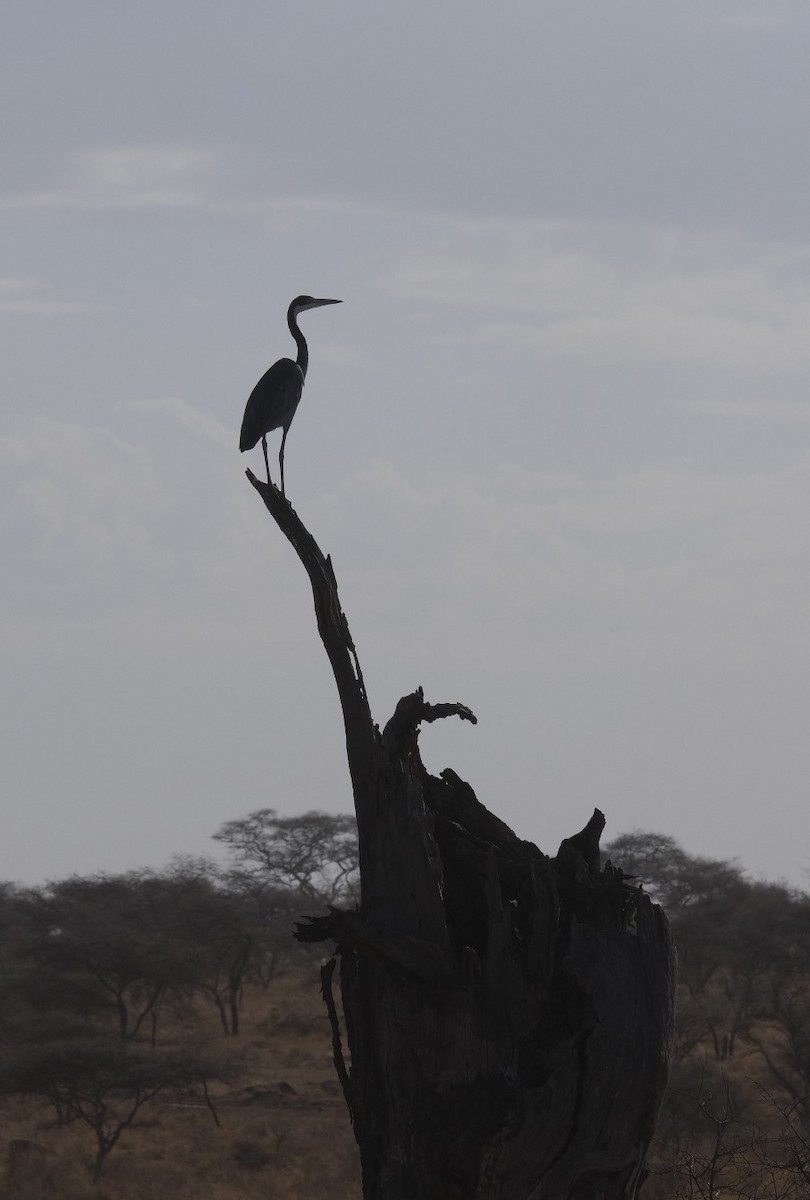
left=605, top=830, right=810, bottom=1122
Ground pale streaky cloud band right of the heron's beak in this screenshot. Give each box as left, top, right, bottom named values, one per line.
left=388, top=221, right=810, bottom=372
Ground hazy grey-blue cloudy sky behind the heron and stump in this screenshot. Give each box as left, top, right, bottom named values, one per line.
left=0, top=0, right=810, bottom=888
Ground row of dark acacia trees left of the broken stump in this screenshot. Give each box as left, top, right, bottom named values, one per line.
left=0, top=809, right=358, bottom=1176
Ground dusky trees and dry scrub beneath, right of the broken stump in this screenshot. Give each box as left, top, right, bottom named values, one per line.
left=605, top=832, right=810, bottom=1200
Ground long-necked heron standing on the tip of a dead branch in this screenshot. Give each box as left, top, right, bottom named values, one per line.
left=239, top=296, right=341, bottom=496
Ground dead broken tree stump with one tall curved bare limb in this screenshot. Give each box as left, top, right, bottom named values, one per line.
left=247, top=472, right=674, bottom=1200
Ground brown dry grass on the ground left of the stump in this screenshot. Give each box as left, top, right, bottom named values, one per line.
left=0, top=967, right=360, bottom=1200
